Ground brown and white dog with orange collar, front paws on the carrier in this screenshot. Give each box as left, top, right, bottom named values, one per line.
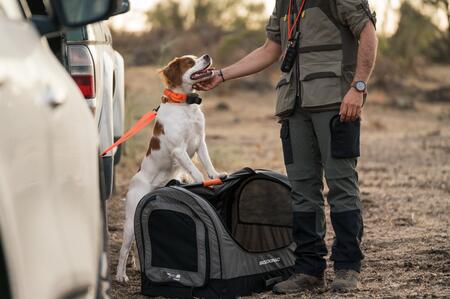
left=116, top=55, right=226, bottom=282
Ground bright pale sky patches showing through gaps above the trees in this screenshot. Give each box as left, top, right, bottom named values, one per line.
left=111, top=0, right=447, bottom=35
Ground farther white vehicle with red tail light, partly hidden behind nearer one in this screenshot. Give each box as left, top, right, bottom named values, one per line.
left=27, top=0, right=129, bottom=198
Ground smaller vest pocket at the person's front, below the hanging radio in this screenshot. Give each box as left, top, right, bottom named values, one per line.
left=275, top=72, right=296, bottom=117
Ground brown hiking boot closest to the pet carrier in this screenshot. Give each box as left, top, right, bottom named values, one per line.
left=273, top=273, right=325, bottom=294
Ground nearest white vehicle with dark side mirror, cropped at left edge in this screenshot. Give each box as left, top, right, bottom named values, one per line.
left=0, top=0, right=121, bottom=299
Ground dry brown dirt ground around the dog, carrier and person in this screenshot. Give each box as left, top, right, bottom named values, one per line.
left=108, top=67, right=450, bottom=298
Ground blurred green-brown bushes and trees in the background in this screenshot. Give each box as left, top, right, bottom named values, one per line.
left=110, top=0, right=450, bottom=88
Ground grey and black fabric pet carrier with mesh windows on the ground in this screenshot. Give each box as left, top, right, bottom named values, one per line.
left=135, top=168, right=295, bottom=299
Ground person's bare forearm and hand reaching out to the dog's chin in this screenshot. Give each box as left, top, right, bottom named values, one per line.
left=195, top=39, right=281, bottom=91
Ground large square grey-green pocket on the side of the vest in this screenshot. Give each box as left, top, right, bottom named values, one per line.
left=300, top=62, right=343, bottom=108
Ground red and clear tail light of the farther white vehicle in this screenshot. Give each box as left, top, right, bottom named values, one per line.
left=68, top=45, right=95, bottom=99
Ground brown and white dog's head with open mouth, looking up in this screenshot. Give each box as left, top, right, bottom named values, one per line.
left=160, top=55, right=213, bottom=88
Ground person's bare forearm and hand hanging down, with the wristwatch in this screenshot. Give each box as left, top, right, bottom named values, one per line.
left=339, top=22, right=378, bottom=121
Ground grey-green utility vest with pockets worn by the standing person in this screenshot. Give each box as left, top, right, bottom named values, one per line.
left=276, top=0, right=374, bottom=117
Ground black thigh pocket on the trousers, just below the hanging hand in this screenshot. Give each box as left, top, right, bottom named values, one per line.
left=330, top=114, right=361, bottom=159
